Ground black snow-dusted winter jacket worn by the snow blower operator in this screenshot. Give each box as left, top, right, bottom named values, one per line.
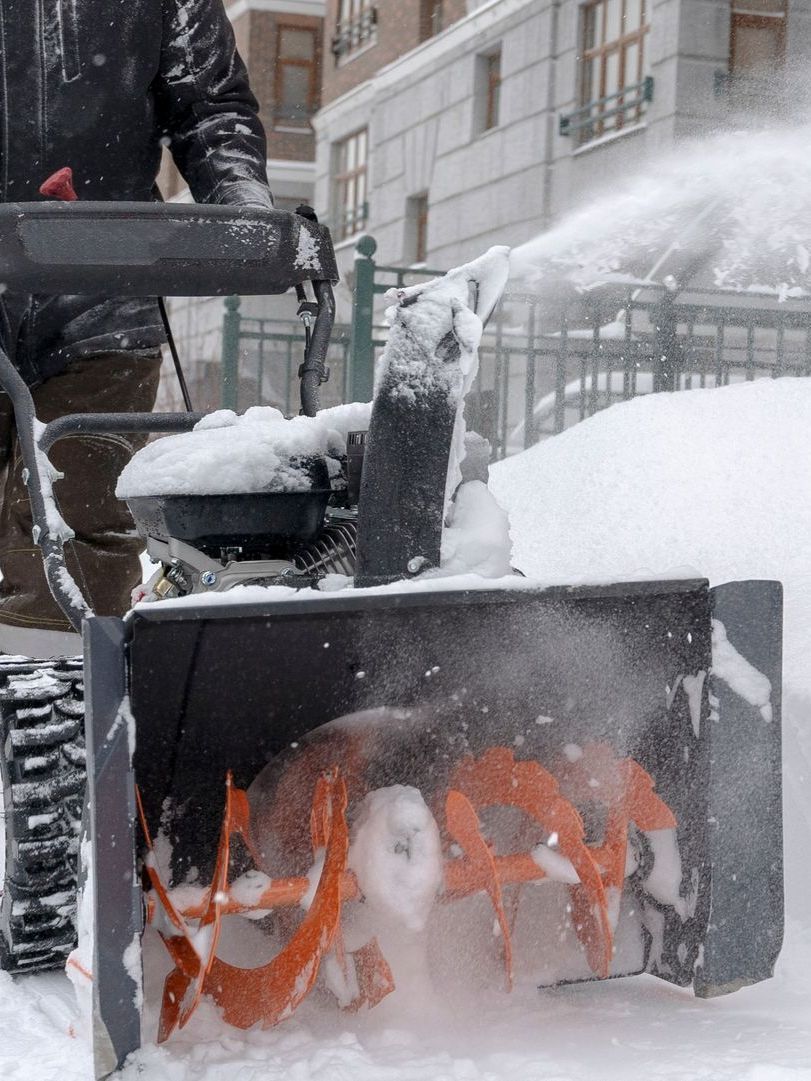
left=0, top=0, right=271, bottom=382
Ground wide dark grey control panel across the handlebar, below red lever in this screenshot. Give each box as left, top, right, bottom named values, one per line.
left=0, top=202, right=338, bottom=296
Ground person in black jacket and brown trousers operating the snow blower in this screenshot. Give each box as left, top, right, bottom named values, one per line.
left=0, top=0, right=272, bottom=657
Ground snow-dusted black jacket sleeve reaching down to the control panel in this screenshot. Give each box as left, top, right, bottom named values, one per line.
left=154, top=0, right=272, bottom=208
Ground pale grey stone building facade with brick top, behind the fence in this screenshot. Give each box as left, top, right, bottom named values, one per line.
left=313, top=0, right=811, bottom=308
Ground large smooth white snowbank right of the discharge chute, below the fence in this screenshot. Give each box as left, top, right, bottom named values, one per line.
left=490, top=378, right=811, bottom=695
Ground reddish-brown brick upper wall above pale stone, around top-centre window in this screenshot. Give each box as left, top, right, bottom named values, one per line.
left=321, top=0, right=467, bottom=105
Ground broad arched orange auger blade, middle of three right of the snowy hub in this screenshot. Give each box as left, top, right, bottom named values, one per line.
left=450, top=747, right=613, bottom=977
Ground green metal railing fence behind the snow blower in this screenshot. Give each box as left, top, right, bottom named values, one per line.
left=214, top=237, right=811, bottom=457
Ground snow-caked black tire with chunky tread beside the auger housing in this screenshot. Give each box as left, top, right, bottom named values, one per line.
left=0, top=657, right=85, bottom=973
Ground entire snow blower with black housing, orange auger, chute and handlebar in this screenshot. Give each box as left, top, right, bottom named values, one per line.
left=0, top=204, right=782, bottom=1077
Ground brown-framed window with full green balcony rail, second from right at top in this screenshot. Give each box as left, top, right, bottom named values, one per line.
left=560, top=0, right=653, bottom=143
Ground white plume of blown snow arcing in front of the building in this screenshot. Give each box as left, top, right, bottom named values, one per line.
left=510, top=123, right=811, bottom=297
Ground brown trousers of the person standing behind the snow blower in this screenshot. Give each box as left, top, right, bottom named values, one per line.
left=0, top=350, right=161, bottom=656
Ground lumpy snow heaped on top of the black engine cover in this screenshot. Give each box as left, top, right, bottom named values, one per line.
left=116, top=404, right=370, bottom=499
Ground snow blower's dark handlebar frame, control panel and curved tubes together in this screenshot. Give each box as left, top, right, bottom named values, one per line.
left=0, top=201, right=338, bottom=630
